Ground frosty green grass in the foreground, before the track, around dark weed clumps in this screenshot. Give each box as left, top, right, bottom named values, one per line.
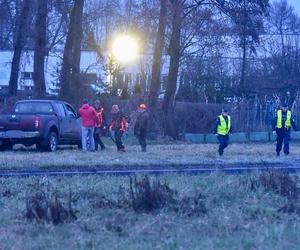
left=0, top=174, right=300, bottom=249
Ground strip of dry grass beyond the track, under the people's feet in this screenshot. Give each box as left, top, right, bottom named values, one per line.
left=0, top=143, right=300, bottom=168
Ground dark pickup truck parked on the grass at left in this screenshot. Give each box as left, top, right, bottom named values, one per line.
left=0, top=100, right=81, bottom=152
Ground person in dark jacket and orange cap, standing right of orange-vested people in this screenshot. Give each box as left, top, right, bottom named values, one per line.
left=134, top=104, right=149, bottom=152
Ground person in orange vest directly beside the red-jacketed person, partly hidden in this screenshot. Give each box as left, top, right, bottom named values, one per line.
left=94, top=100, right=105, bottom=151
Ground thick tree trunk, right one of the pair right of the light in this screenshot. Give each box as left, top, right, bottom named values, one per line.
left=163, top=0, right=183, bottom=139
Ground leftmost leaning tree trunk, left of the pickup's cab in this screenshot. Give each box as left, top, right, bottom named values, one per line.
left=9, top=0, right=31, bottom=96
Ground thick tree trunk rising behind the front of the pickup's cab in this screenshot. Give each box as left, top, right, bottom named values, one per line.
left=60, top=0, right=84, bottom=98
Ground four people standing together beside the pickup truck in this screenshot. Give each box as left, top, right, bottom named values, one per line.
left=79, top=99, right=149, bottom=152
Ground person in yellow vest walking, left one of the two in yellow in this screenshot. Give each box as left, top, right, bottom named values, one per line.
left=214, top=109, right=232, bottom=156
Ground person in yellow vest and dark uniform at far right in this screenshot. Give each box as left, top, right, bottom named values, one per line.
left=272, top=103, right=297, bottom=156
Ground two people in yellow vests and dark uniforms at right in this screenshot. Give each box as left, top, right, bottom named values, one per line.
left=214, top=104, right=297, bottom=156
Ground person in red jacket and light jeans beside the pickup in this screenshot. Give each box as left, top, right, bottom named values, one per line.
left=79, top=99, right=99, bottom=152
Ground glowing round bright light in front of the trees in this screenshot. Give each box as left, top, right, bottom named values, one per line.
left=112, top=35, right=139, bottom=63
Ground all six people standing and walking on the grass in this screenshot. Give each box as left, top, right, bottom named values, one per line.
left=79, top=100, right=297, bottom=156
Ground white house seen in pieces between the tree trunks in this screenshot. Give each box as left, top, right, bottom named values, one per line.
left=0, top=50, right=168, bottom=95
